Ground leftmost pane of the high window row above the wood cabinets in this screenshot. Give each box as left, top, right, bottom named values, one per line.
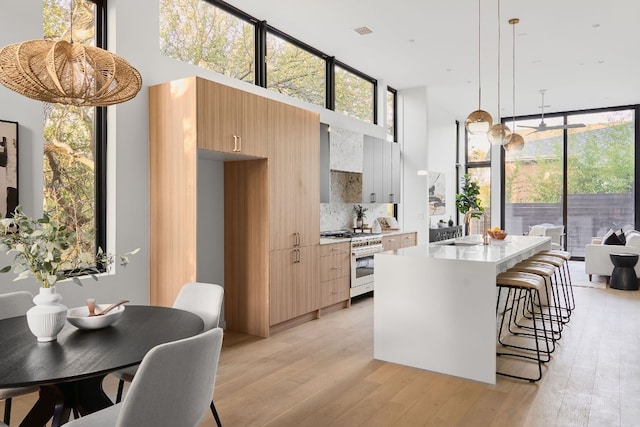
left=160, top=0, right=255, bottom=83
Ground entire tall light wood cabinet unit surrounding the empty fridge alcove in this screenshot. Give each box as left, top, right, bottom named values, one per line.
left=149, top=77, right=320, bottom=337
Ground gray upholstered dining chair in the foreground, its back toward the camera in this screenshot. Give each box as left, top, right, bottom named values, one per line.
left=66, top=328, right=222, bottom=427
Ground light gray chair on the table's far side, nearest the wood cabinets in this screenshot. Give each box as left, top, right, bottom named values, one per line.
left=113, top=282, right=224, bottom=427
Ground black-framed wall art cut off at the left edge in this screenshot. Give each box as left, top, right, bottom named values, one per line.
left=0, top=120, right=18, bottom=218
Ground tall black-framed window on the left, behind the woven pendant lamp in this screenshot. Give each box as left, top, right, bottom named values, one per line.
left=43, top=0, right=107, bottom=262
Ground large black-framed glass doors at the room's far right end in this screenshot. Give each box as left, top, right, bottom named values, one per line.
left=504, top=107, right=638, bottom=258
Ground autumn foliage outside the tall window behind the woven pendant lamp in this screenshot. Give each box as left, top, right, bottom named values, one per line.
left=43, top=0, right=97, bottom=266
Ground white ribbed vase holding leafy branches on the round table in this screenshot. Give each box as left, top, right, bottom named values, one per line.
left=27, top=287, right=67, bottom=342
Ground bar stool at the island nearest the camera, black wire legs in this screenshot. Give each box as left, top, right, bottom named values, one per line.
left=496, top=271, right=551, bottom=382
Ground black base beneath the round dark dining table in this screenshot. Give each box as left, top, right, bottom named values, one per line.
left=20, top=375, right=113, bottom=427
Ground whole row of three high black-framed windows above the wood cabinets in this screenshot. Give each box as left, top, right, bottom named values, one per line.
left=160, top=0, right=378, bottom=126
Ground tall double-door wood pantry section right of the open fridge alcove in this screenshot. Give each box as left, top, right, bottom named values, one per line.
left=267, top=103, right=320, bottom=326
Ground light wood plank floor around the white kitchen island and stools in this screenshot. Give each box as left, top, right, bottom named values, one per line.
left=6, top=263, right=640, bottom=427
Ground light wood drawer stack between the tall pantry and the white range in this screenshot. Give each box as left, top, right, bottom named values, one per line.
left=320, top=242, right=351, bottom=308
